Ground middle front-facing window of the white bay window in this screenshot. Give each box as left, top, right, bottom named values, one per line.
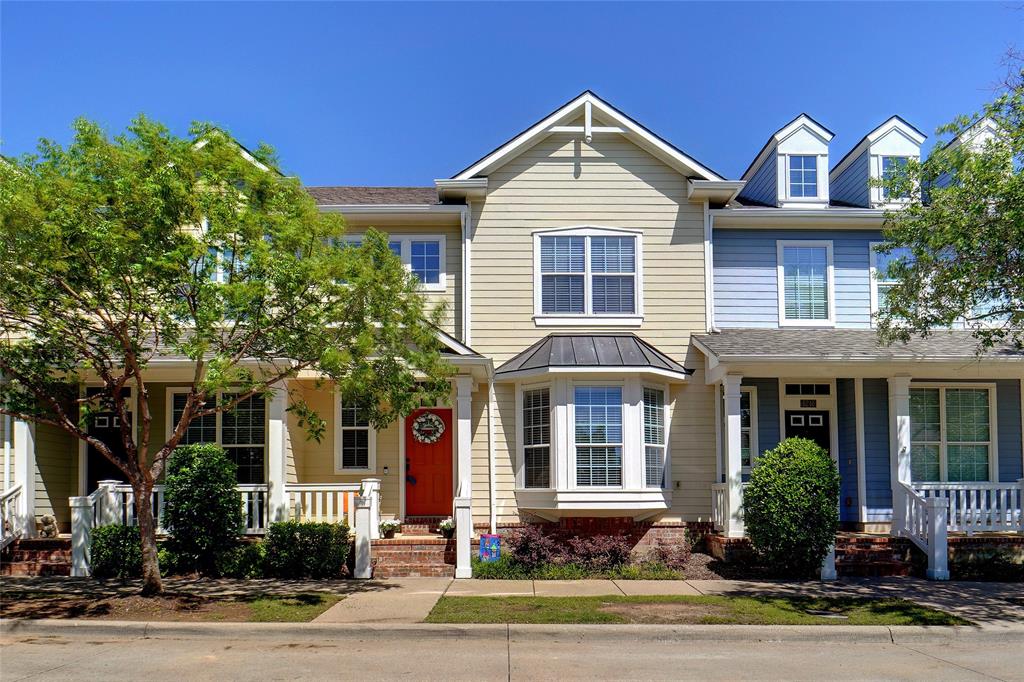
left=573, top=386, right=623, bottom=486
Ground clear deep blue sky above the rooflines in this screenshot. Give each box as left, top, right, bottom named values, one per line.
left=0, top=0, right=1024, bottom=185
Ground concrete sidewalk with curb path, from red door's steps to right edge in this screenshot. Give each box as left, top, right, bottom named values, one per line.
left=315, top=578, right=1024, bottom=627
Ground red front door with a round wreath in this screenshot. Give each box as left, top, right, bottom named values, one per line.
left=406, top=408, right=452, bottom=516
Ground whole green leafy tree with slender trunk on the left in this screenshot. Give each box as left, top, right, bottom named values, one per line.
left=0, top=118, right=450, bottom=594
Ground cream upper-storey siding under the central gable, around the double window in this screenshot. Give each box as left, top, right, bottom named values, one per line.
left=472, top=134, right=705, bottom=365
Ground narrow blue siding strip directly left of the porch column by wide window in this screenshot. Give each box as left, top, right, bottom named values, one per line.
left=864, top=379, right=893, bottom=521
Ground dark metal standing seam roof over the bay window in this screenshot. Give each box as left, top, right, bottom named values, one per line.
left=496, top=334, right=693, bottom=376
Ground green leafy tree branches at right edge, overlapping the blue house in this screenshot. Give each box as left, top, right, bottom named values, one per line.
left=879, top=71, right=1024, bottom=350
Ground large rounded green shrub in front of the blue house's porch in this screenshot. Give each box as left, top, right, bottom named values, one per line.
left=743, top=438, right=840, bottom=578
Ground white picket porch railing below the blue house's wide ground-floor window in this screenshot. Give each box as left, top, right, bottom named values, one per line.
left=912, top=479, right=1024, bottom=535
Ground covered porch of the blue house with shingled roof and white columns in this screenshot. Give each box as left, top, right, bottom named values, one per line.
left=695, top=330, right=1024, bottom=580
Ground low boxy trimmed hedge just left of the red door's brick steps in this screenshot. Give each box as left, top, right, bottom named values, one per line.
left=265, top=521, right=349, bottom=578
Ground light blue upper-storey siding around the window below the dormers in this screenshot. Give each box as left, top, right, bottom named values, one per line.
left=714, top=229, right=882, bottom=328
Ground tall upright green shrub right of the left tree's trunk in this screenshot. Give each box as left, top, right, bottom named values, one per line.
left=164, top=444, right=243, bottom=576
